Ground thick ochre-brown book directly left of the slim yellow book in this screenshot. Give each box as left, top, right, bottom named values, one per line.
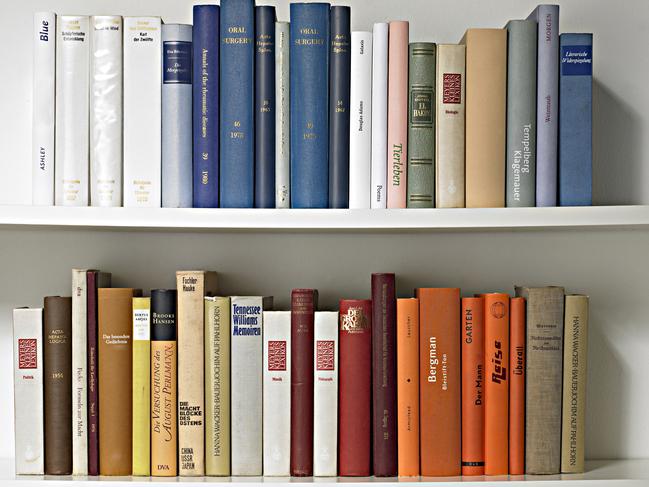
left=97, top=288, right=142, bottom=475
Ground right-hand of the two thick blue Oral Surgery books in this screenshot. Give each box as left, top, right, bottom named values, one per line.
left=289, top=3, right=329, bottom=208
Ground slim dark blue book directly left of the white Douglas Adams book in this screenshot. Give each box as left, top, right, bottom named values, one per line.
left=329, top=6, right=351, bottom=208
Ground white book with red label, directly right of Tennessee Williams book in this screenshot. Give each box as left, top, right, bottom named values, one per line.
left=263, top=311, right=291, bottom=477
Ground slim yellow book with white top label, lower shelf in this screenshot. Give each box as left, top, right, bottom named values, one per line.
left=132, top=298, right=151, bottom=477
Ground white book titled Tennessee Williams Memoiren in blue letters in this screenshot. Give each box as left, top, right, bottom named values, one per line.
left=230, top=296, right=272, bottom=476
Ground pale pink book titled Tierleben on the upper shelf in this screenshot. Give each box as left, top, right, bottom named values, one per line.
left=387, top=21, right=408, bottom=208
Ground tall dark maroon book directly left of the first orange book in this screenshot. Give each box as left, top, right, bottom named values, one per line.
left=372, top=274, right=398, bottom=477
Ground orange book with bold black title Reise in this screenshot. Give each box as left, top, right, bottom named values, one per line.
left=483, top=293, right=509, bottom=475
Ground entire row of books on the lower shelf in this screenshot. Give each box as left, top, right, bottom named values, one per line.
left=14, top=270, right=588, bottom=477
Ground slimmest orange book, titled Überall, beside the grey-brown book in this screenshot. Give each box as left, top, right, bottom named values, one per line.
left=509, top=298, right=526, bottom=475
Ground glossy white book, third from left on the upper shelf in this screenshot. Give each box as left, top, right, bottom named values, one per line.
left=90, top=15, right=123, bottom=206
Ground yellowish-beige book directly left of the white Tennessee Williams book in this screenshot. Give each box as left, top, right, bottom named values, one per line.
left=205, top=296, right=230, bottom=476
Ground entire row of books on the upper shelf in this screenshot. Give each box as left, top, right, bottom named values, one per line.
left=32, top=0, right=592, bottom=212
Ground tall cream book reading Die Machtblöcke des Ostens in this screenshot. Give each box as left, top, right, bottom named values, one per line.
left=176, top=271, right=216, bottom=476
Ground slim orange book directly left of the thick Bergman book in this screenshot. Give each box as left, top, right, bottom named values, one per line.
left=397, top=298, right=419, bottom=477
